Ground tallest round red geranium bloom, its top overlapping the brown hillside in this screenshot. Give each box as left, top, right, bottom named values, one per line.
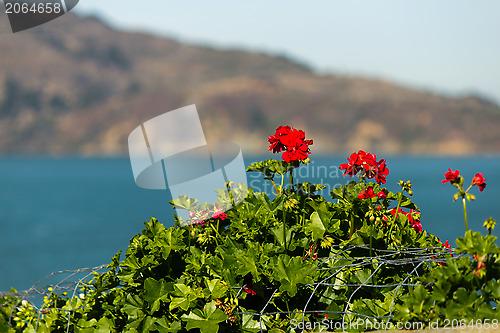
left=268, top=126, right=313, bottom=163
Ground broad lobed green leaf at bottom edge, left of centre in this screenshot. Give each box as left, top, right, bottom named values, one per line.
left=181, top=301, right=228, bottom=333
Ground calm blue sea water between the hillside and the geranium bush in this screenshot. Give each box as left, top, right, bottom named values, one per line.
left=0, top=156, right=500, bottom=291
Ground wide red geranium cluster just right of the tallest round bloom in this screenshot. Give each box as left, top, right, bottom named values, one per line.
left=339, top=150, right=389, bottom=184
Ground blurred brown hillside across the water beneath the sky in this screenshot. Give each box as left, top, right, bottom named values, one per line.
left=0, top=13, right=500, bottom=155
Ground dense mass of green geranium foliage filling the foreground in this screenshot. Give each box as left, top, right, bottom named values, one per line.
left=0, top=160, right=500, bottom=333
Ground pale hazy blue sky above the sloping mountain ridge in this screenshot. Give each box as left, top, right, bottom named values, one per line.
left=12, top=0, right=500, bottom=102
